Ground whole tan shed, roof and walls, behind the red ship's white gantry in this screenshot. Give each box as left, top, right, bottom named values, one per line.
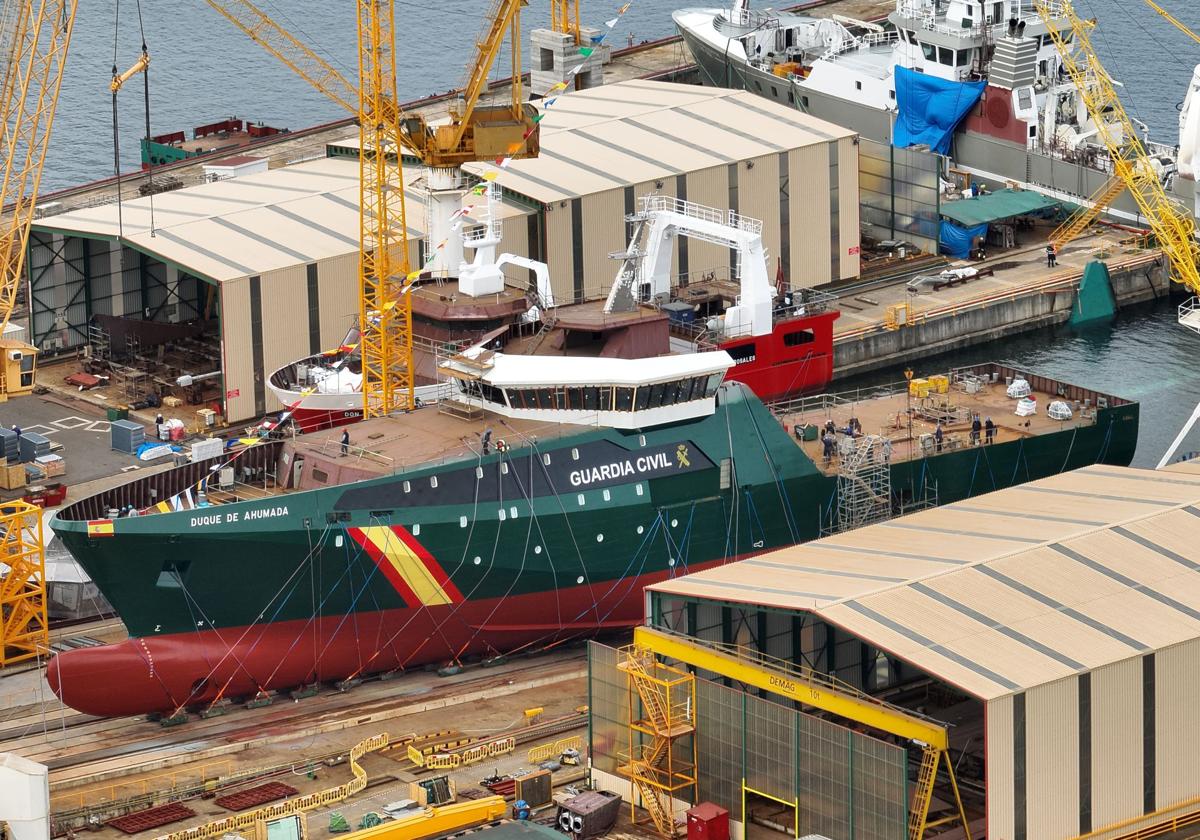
left=466, top=80, right=859, bottom=301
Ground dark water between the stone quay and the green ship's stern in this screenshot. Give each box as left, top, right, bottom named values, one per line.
left=834, top=299, right=1200, bottom=467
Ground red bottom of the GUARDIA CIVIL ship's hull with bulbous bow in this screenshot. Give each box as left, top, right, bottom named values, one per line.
left=46, top=564, right=715, bottom=716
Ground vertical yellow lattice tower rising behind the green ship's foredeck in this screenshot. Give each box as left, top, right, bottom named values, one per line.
left=358, top=0, right=415, bottom=419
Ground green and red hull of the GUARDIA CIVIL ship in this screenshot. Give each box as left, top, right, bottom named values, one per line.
left=48, top=384, right=1139, bottom=715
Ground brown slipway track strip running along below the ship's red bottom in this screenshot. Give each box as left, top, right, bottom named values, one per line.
left=0, top=650, right=586, bottom=790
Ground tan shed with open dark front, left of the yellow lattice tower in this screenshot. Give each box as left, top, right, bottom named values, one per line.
left=29, top=158, right=470, bottom=419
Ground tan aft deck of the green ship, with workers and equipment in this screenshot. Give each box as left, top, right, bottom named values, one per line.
left=772, top=365, right=1126, bottom=475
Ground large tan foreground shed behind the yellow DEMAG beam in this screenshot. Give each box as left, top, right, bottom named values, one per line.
left=592, top=464, right=1200, bottom=840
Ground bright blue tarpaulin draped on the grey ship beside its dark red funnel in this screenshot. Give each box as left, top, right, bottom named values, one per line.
left=892, top=65, right=986, bottom=155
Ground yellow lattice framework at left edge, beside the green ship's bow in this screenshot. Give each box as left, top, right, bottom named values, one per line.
left=0, top=502, right=50, bottom=667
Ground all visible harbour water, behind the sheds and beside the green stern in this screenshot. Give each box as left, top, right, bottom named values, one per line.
left=42, top=0, right=1200, bottom=464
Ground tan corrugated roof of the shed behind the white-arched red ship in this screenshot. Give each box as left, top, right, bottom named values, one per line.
left=463, top=79, right=854, bottom=204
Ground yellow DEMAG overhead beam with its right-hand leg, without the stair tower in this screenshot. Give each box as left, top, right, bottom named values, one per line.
left=634, top=626, right=971, bottom=840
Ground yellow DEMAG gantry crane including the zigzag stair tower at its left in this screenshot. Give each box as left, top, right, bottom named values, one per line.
left=618, top=626, right=971, bottom=840
